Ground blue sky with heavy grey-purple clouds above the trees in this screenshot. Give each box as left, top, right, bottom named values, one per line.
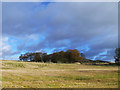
left=0, top=2, right=118, bottom=61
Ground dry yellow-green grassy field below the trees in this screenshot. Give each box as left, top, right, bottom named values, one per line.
left=2, top=60, right=118, bottom=88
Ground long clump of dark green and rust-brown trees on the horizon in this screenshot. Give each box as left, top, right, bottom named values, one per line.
left=19, top=49, right=85, bottom=63
